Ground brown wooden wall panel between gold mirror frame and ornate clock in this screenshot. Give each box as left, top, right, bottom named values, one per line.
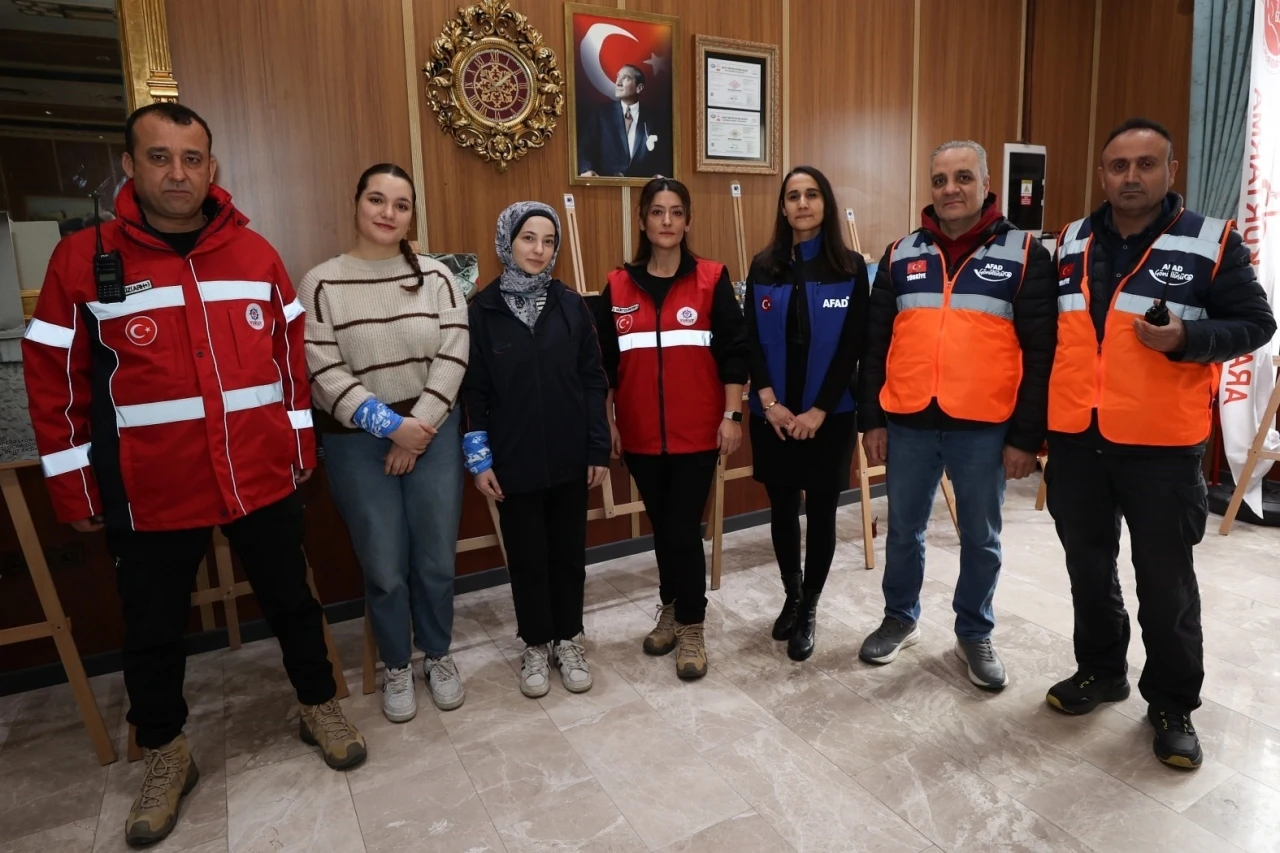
left=166, top=0, right=421, bottom=279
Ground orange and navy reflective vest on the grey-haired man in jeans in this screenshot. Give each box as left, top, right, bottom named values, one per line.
left=881, top=231, right=1032, bottom=423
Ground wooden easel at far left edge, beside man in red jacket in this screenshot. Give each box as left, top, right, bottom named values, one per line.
left=0, top=461, right=115, bottom=765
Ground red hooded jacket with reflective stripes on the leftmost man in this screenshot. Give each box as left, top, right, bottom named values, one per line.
left=22, top=182, right=315, bottom=530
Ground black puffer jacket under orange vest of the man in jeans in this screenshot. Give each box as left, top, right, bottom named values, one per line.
left=858, top=218, right=1057, bottom=453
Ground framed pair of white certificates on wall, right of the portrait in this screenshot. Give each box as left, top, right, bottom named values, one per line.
left=695, top=36, right=781, bottom=174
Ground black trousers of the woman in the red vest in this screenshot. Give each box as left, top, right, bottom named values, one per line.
left=626, top=451, right=717, bottom=625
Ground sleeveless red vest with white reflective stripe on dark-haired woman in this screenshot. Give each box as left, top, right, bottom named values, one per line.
left=608, top=259, right=724, bottom=453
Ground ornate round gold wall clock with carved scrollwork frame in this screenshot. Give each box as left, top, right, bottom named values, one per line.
left=422, top=0, right=564, bottom=172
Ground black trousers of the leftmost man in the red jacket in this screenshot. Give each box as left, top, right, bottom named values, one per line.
left=106, top=493, right=338, bottom=748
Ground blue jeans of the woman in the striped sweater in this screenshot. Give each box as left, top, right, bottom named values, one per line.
left=324, top=410, right=462, bottom=667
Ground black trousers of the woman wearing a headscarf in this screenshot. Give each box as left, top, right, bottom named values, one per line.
left=498, top=481, right=586, bottom=646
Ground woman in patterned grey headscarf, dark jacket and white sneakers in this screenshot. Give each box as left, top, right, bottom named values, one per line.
left=462, top=201, right=609, bottom=698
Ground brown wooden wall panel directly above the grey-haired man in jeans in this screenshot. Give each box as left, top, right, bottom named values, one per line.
left=916, top=0, right=1023, bottom=225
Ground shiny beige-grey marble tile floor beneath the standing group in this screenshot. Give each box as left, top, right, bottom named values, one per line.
left=0, top=480, right=1280, bottom=853
